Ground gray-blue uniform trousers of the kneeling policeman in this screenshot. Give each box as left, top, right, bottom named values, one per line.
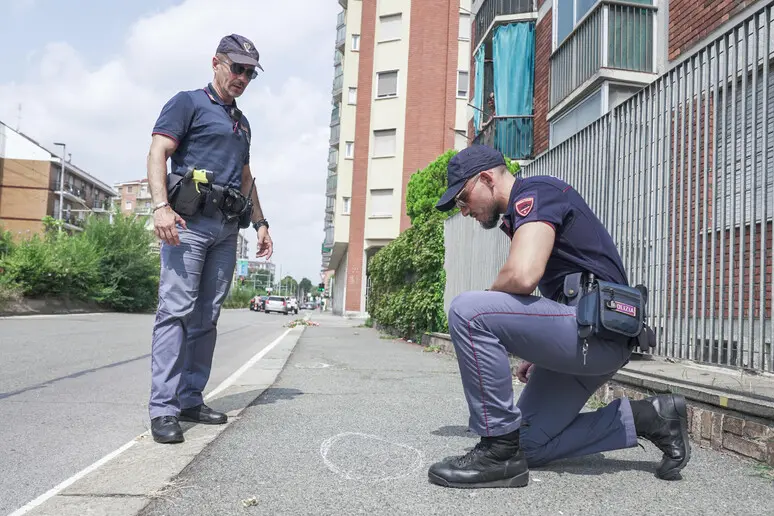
left=449, top=291, right=637, bottom=467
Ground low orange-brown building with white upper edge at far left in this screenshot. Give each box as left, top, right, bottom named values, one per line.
left=0, top=122, right=117, bottom=238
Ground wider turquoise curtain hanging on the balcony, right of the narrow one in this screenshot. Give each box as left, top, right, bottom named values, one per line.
left=492, top=22, right=535, bottom=159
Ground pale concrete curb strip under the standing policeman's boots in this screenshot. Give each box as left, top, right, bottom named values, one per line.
left=25, top=326, right=306, bottom=516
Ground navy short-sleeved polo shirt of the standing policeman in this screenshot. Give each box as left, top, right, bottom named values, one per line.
left=153, top=84, right=255, bottom=188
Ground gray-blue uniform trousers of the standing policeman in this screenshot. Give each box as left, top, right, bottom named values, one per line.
left=149, top=212, right=239, bottom=419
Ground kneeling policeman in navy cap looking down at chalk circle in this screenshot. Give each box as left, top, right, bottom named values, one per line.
left=428, top=146, right=690, bottom=487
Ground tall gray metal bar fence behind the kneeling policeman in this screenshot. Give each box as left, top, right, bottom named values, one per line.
left=445, top=2, right=774, bottom=372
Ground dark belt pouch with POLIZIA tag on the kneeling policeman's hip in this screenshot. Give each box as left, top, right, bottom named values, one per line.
left=577, top=280, right=645, bottom=343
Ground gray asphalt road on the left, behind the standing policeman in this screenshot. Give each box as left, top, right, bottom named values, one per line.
left=0, top=310, right=293, bottom=514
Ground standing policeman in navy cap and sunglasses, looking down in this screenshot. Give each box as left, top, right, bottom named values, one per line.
left=148, top=34, right=273, bottom=443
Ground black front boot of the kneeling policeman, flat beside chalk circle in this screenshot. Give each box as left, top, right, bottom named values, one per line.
left=428, top=430, right=529, bottom=489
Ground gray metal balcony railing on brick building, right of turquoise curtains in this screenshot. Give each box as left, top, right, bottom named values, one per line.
left=551, top=1, right=656, bottom=108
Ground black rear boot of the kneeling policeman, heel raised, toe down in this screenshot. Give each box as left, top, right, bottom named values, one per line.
left=630, top=394, right=691, bottom=480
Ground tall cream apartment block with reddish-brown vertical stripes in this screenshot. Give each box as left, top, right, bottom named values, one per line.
left=322, top=0, right=472, bottom=314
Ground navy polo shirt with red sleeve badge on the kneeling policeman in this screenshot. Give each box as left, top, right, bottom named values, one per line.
left=500, top=176, right=629, bottom=300
